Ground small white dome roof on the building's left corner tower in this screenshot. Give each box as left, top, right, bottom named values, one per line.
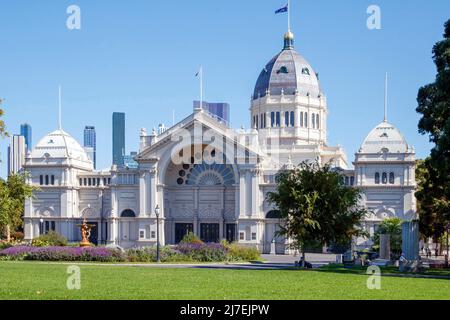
left=31, top=130, right=92, bottom=163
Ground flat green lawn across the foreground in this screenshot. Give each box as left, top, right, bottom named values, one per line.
left=0, top=262, right=450, bottom=300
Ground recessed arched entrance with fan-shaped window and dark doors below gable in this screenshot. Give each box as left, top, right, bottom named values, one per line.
left=163, top=146, right=237, bottom=244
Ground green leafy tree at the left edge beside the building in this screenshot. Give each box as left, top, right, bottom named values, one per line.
left=0, top=173, right=36, bottom=242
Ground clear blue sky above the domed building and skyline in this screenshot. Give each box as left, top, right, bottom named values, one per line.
left=0, top=0, right=450, bottom=176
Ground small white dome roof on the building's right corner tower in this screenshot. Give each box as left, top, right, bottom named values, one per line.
left=359, top=121, right=409, bottom=153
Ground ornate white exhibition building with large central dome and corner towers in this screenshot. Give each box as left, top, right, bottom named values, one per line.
left=24, top=32, right=416, bottom=253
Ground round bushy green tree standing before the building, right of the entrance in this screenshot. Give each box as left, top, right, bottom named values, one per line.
left=267, top=162, right=367, bottom=262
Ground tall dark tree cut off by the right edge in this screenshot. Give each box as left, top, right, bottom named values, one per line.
left=416, top=20, right=450, bottom=245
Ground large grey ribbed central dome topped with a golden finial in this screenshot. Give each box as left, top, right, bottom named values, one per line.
left=253, top=32, right=321, bottom=99
